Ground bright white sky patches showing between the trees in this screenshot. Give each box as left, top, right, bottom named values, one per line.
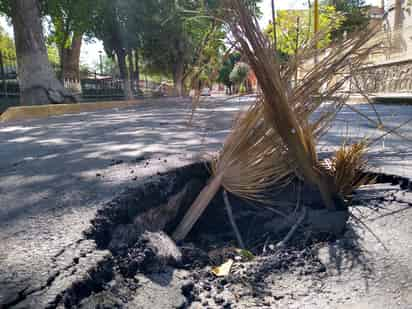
left=0, top=0, right=380, bottom=67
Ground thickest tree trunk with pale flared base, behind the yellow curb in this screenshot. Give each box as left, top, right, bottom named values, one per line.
left=11, top=0, right=76, bottom=105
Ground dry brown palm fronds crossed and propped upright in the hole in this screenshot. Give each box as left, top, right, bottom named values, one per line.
left=173, top=0, right=382, bottom=240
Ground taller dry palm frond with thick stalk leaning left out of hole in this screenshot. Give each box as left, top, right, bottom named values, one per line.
left=219, top=0, right=380, bottom=208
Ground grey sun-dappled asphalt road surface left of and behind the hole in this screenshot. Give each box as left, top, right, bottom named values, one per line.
left=0, top=99, right=412, bottom=308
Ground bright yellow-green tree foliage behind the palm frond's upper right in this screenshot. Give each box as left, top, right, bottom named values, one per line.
left=265, top=6, right=345, bottom=56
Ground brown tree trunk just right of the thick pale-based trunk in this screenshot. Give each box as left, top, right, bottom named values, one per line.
left=60, top=33, right=83, bottom=80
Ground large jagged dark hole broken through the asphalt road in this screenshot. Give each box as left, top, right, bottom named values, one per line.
left=61, top=162, right=411, bottom=308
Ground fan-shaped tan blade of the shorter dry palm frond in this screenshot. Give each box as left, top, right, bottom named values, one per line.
left=212, top=101, right=296, bottom=201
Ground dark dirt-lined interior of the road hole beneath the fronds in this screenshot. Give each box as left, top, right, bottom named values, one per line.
left=87, top=162, right=349, bottom=270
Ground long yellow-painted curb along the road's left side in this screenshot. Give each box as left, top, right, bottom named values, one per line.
left=0, top=100, right=143, bottom=122
